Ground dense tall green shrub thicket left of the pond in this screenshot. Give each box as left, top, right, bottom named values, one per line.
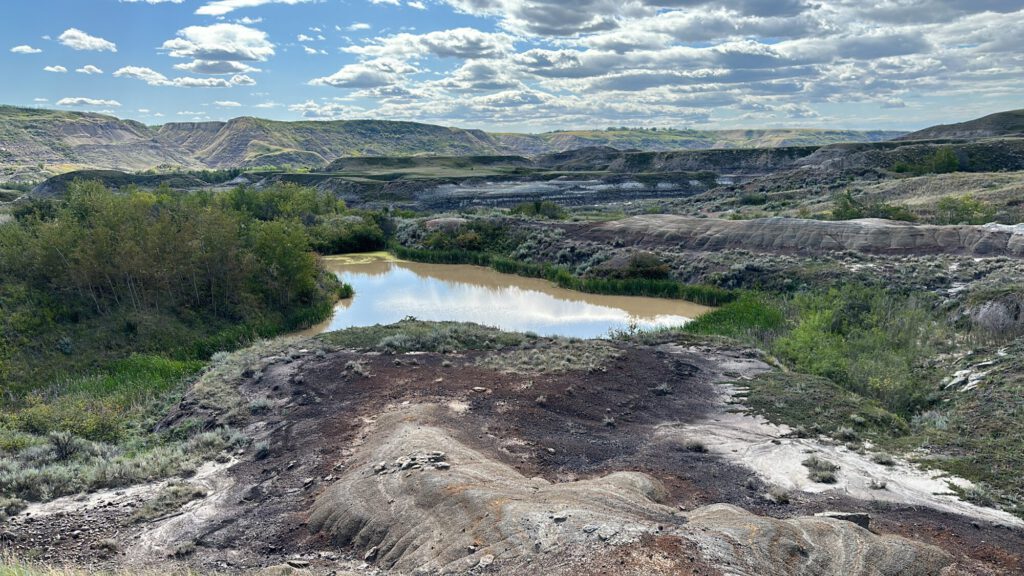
left=0, top=182, right=350, bottom=393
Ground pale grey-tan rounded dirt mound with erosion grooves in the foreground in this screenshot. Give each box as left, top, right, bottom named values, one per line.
left=309, top=407, right=953, bottom=576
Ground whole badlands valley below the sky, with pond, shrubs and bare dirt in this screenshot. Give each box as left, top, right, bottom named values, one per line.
left=0, top=111, right=1024, bottom=576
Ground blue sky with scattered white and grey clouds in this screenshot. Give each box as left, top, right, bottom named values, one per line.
left=0, top=0, right=1024, bottom=132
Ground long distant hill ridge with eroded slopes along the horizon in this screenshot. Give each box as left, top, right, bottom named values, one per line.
left=0, top=106, right=913, bottom=181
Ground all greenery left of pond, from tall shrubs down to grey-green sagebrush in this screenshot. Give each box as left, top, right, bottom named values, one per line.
left=0, top=181, right=384, bottom=500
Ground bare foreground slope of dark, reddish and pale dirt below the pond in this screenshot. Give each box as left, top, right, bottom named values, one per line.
left=4, top=330, right=1024, bottom=576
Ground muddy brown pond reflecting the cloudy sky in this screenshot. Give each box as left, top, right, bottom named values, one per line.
left=303, top=253, right=711, bottom=338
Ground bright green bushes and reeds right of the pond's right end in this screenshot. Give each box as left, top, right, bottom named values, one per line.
left=684, top=286, right=949, bottom=418
